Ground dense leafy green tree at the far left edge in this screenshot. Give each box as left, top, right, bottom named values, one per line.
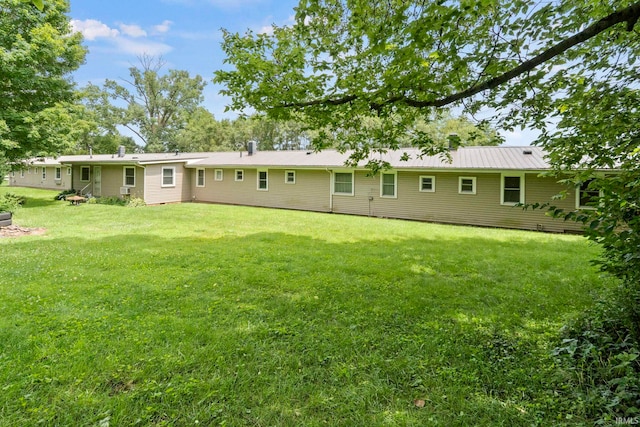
left=0, top=0, right=85, bottom=162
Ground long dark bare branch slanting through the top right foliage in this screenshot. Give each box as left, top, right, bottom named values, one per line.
left=279, top=2, right=640, bottom=110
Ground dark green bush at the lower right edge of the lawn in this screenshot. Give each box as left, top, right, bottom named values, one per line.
left=553, top=284, right=640, bottom=424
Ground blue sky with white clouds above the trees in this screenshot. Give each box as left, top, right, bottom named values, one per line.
left=70, top=0, right=533, bottom=145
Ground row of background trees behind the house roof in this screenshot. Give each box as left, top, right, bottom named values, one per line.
left=77, top=56, right=499, bottom=156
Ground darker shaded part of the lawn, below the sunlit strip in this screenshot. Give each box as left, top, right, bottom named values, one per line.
left=0, top=233, right=604, bottom=425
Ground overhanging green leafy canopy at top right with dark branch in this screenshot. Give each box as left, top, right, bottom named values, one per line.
left=216, top=0, right=640, bottom=158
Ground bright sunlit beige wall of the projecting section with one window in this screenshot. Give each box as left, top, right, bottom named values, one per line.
left=145, top=163, right=195, bottom=205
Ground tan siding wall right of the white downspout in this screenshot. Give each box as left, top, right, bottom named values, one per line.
left=333, top=171, right=580, bottom=232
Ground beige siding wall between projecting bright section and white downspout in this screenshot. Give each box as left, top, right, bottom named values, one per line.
left=192, top=168, right=331, bottom=212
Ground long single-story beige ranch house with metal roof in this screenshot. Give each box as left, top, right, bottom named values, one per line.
left=9, top=146, right=597, bottom=232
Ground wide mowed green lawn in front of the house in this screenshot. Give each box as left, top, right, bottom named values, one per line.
left=0, top=187, right=609, bottom=427
